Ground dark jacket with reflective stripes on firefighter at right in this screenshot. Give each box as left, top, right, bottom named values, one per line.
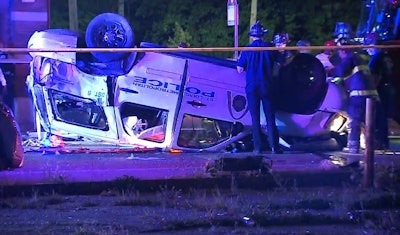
left=330, top=52, right=378, bottom=97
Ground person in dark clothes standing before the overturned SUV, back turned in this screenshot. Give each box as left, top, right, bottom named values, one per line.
left=237, top=21, right=285, bottom=154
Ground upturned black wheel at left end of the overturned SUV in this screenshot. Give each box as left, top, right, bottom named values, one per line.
left=85, top=13, right=134, bottom=62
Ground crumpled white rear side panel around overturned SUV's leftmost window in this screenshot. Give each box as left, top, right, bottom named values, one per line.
left=32, top=57, right=117, bottom=142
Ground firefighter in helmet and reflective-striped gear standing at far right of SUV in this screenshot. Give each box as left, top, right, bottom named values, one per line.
left=328, top=22, right=378, bottom=153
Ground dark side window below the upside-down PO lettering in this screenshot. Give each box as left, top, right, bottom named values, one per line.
left=178, top=114, right=233, bottom=148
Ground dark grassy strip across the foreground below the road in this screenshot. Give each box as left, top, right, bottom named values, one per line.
left=0, top=163, right=400, bottom=234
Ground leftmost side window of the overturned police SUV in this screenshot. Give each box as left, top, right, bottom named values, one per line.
left=49, top=90, right=108, bottom=130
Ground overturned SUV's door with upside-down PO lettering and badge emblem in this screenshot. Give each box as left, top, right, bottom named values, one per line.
left=174, top=58, right=251, bottom=150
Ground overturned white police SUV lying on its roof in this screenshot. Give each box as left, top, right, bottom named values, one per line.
left=27, top=13, right=347, bottom=151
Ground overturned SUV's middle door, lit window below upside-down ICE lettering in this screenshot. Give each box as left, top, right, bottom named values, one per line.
left=115, top=52, right=186, bottom=148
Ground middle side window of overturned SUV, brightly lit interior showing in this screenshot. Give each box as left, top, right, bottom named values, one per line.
left=121, top=103, right=168, bottom=143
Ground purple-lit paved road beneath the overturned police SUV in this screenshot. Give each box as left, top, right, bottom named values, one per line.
left=0, top=138, right=400, bottom=196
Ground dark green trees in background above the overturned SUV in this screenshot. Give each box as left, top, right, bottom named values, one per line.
left=51, top=0, right=362, bottom=57
